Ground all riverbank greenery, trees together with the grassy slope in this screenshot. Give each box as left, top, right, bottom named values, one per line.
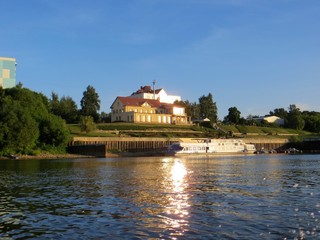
left=0, top=84, right=320, bottom=156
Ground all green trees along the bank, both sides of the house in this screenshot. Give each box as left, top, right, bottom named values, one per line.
left=0, top=84, right=320, bottom=155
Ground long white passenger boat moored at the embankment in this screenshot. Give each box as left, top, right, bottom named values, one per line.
left=168, top=138, right=256, bottom=155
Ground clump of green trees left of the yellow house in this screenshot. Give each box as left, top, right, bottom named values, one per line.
left=0, top=84, right=101, bottom=155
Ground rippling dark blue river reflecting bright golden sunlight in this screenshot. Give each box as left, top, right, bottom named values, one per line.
left=0, top=154, right=320, bottom=239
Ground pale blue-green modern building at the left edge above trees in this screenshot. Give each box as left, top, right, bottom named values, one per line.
left=0, top=57, right=17, bottom=88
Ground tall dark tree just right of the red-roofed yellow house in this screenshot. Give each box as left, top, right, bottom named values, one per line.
left=199, top=93, right=218, bottom=123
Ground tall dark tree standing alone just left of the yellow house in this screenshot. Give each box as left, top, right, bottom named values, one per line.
left=80, top=85, right=100, bottom=122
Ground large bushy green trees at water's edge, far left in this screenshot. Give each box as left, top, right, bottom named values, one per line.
left=0, top=86, right=67, bottom=153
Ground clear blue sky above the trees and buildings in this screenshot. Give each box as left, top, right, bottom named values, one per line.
left=0, top=0, right=320, bottom=119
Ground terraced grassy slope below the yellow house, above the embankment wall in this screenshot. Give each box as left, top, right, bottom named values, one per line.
left=69, top=123, right=311, bottom=138
